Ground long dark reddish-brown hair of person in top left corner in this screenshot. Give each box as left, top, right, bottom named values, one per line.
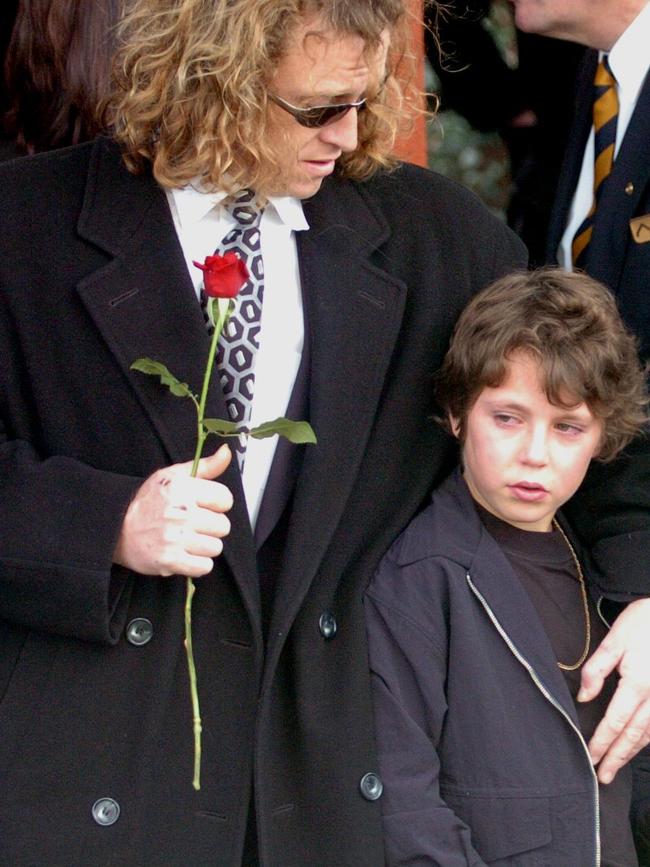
left=0, top=0, right=122, bottom=159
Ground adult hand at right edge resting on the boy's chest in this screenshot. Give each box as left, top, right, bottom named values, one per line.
left=578, top=598, right=650, bottom=783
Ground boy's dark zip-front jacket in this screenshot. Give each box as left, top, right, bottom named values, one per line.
left=365, top=472, right=598, bottom=867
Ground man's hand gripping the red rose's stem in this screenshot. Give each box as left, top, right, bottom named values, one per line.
left=113, top=445, right=233, bottom=578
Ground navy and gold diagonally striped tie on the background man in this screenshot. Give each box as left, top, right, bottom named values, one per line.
left=571, top=55, right=618, bottom=268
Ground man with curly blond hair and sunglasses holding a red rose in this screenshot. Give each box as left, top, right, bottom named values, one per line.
left=0, top=0, right=650, bottom=867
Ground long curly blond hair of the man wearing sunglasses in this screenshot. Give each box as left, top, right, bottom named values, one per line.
left=105, top=0, right=420, bottom=191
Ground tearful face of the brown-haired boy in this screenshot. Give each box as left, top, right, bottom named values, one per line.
left=452, top=352, right=602, bottom=532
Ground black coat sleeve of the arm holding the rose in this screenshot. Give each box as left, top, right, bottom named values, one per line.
left=0, top=299, right=142, bottom=643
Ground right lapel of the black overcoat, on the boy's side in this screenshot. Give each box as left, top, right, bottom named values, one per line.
left=264, top=180, right=406, bottom=634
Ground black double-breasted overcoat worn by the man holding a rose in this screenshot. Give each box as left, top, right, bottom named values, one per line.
left=0, top=140, right=525, bottom=867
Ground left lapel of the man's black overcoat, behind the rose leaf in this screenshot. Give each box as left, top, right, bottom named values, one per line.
left=71, top=139, right=259, bottom=624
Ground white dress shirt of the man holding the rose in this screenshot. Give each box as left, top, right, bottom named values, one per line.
left=167, top=186, right=309, bottom=528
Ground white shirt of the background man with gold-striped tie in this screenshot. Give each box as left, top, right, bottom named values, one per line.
left=558, top=3, right=650, bottom=271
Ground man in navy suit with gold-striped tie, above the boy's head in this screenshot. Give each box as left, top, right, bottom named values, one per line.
left=514, top=0, right=650, bottom=358
